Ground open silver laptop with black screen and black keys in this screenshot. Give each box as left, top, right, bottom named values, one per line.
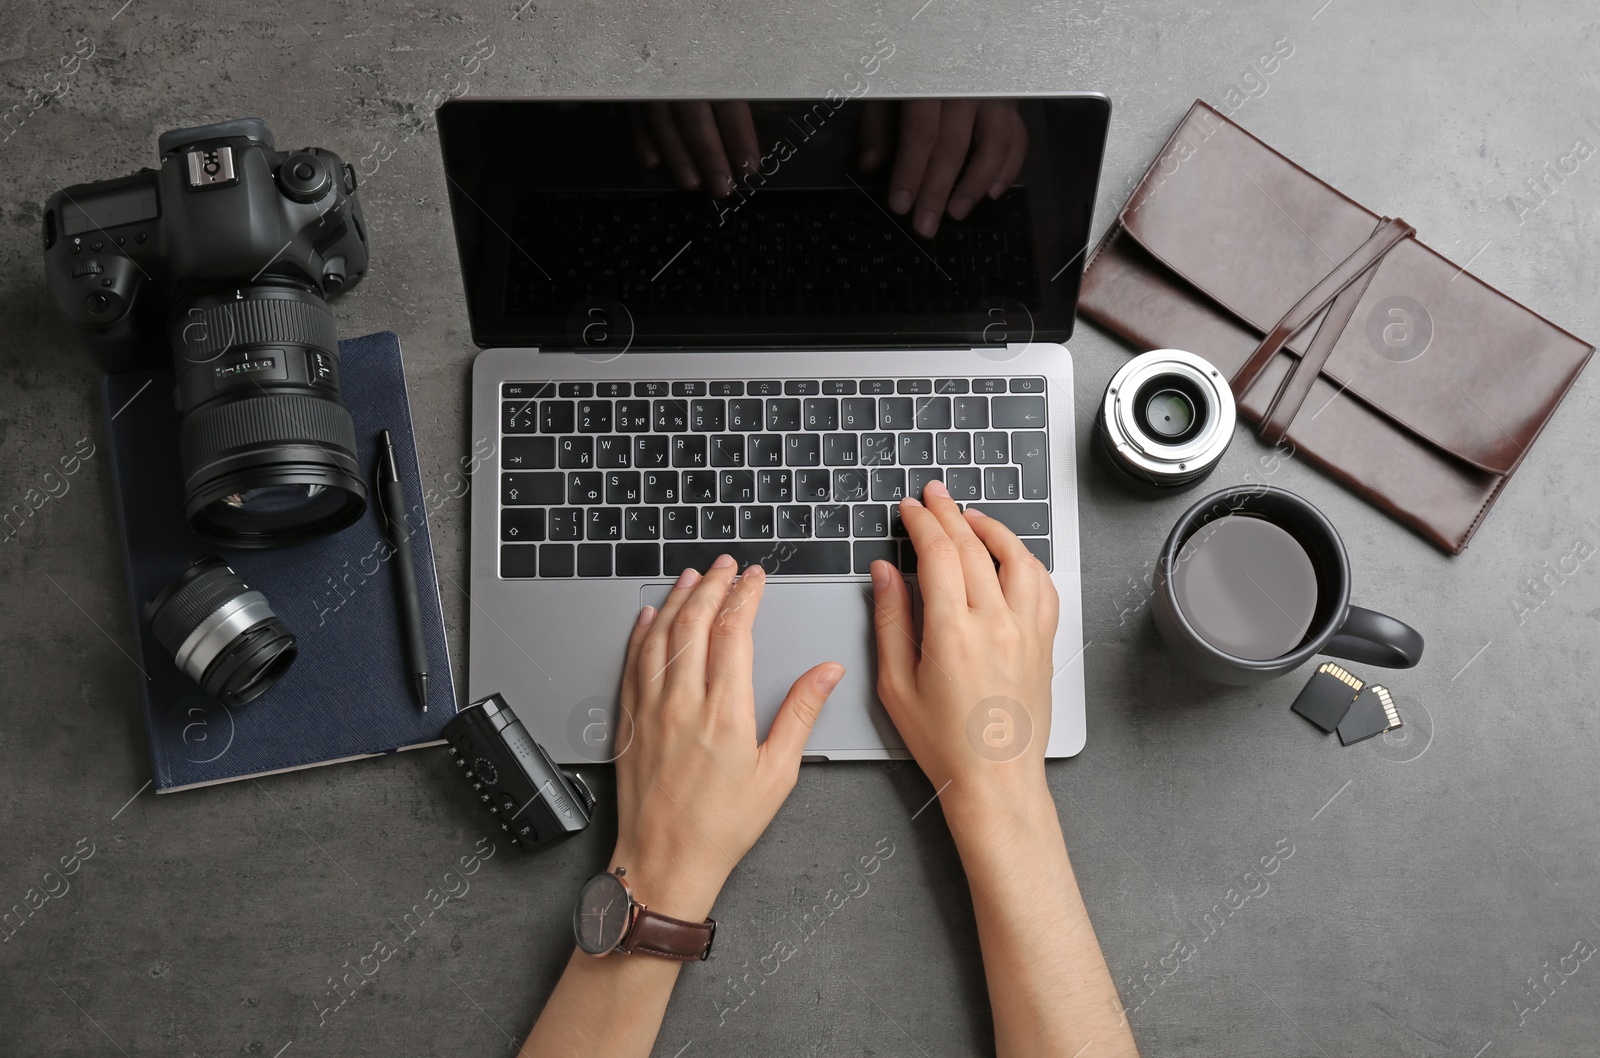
left=438, top=93, right=1110, bottom=763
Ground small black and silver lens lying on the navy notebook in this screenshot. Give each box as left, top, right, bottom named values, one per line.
left=144, top=557, right=296, bottom=706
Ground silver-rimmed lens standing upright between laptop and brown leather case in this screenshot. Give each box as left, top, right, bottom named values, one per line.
left=1094, top=349, right=1237, bottom=496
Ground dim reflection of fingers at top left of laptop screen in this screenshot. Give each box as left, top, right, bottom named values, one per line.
left=629, top=99, right=762, bottom=198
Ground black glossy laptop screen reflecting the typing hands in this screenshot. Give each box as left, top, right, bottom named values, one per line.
left=438, top=96, right=1110, bottom=352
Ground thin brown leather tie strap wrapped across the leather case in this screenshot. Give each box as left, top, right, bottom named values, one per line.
left=1230, top=216, right=1416, bottom=443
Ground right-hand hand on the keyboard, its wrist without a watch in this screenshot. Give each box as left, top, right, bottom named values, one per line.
left=872, top=482, right=1059, bottom=815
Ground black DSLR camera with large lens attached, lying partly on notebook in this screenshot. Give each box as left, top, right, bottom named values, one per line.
left=43, top=117, right=368, bottom=547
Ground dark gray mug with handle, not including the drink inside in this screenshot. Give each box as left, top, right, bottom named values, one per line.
left=1152, top=485, right=1422, bottom=685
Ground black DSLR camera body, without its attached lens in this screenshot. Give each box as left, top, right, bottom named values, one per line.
left=43, top=117, right=368, bottom=370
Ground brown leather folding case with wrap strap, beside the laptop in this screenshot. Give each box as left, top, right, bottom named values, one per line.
left=1078, top=101, right=1594, bottom=554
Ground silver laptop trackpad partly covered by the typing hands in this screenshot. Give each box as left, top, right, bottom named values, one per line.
left=638, top=581, right=906, bottom=759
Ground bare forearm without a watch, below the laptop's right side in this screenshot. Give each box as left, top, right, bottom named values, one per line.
left=946, top=776, right=1138, bottom=1058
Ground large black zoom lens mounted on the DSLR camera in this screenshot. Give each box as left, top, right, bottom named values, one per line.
left=168, top=283, right=366, bottom=547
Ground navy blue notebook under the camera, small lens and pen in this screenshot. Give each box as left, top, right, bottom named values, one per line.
left=102, top=331, right=456, bottom=792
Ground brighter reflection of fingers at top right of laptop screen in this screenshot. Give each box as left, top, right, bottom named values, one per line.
left=859, top=99, right=1027, bottom=238
